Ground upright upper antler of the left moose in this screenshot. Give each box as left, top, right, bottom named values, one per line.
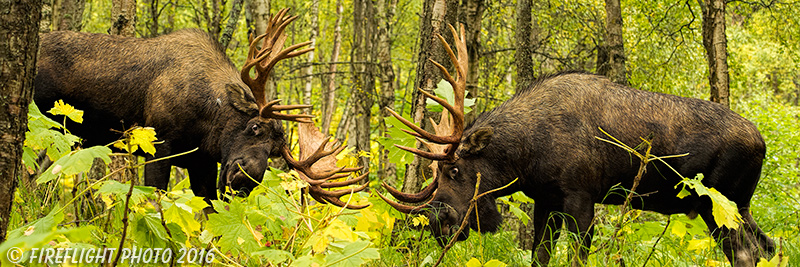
left=241, top=8, right=314, bottom=122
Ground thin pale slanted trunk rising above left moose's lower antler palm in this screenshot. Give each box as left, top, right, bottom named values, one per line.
left=320, top=0, right=344, bottom=134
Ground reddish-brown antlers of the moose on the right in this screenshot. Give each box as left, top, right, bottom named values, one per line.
left=378, top=25, right=469, bottom=214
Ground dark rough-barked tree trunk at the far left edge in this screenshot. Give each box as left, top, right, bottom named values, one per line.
left=0, top=0, right=42, bottom=243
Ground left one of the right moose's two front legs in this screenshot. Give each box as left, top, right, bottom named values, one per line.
left=531, top=202, right=563, bottom=266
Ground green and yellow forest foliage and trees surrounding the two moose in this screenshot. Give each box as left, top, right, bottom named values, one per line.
left=0, top=0, right=800, bottom=266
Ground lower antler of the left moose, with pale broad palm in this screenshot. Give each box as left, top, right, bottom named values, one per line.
left=281, top=123, right=369, bottom=209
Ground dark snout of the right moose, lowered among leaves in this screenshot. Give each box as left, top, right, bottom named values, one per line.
left=428, top=202, right=469, bottom=247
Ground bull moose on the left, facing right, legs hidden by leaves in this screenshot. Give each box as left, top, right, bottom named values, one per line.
left=34, top=9, right=366, bottom=205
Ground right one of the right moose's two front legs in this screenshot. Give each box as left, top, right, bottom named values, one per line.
left=564, top=193, right=594, bottom=266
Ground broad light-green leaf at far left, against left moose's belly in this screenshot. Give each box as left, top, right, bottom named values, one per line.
left=36, top=146, right=111, bottom=184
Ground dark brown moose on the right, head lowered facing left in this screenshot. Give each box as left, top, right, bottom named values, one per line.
left=384, top=24, right=775, bottom=266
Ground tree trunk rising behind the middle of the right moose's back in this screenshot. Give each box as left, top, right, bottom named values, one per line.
left=597, top=0, right=628, bottom=85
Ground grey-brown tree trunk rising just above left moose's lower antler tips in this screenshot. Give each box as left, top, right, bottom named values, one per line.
left=347, top=0, right=376, bottom=172
